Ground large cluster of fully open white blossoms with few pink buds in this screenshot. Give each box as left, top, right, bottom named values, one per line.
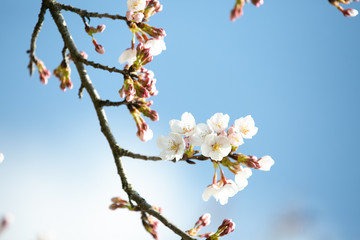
left=157, top=112, right=274, bottom=204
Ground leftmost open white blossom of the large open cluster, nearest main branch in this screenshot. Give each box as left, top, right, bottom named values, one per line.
left=156, top=133, right=185, bottom=161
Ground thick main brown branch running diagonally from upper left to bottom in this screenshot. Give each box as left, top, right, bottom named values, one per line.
left=43, top=0, right=195, bottom=240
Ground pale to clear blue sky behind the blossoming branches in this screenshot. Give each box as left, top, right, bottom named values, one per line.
left=0, top=0, right=360, bottom=240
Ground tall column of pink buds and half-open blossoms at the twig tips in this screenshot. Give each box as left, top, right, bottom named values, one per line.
left=119, top=0, right=166, bottom=142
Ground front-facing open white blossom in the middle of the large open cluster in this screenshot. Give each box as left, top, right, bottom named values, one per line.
left=201, top=134, right=231, bottom=161
